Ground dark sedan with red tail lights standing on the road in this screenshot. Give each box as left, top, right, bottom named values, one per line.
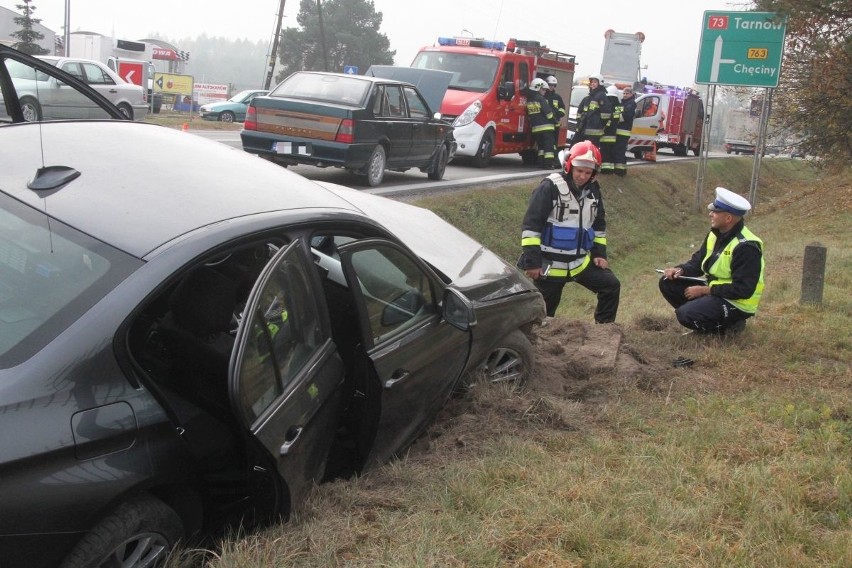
left=240, top=71, right=456, bottom=186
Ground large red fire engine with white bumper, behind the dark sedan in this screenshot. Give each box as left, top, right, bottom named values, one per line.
left=411, top=37, right=575, bottom=167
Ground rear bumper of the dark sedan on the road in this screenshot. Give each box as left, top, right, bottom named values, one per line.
left=240, top=130, right=376, bottom=170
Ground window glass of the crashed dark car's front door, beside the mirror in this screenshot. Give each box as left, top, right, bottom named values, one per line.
left=351, top=244, right=437, bottom=344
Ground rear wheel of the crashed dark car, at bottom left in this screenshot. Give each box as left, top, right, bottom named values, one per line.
left=61, top=495, right=184, bottom=568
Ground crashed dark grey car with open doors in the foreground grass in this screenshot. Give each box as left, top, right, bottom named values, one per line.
left=0, top=46, right=544, bottom=568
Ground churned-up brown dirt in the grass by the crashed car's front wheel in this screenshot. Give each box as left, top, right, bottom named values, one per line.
left=408, top=319, right=673, bottom=461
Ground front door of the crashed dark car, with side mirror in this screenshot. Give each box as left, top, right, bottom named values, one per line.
left=339, top=239, right=470, bottom=465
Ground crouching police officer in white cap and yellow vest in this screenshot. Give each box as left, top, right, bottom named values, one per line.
left=660, top=187, right=765, bottom=335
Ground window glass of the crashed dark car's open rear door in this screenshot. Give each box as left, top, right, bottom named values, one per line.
left=238, top=242, right=325, bottom=421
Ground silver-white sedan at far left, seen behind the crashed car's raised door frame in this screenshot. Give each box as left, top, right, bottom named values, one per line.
left=13, top=56, right=148, bottom=121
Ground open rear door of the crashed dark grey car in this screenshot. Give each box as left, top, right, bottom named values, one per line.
left=229, top=241, right=344, bottom=503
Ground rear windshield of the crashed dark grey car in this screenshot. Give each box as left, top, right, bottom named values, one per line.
left=0, top=193, right=141, bottom=368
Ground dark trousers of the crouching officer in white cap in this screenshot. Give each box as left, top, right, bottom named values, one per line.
left=660, top=278, right=751, bottom=333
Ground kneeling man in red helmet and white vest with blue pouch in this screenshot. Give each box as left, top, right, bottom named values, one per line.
left=518, top=140, right=621, bottom=323
